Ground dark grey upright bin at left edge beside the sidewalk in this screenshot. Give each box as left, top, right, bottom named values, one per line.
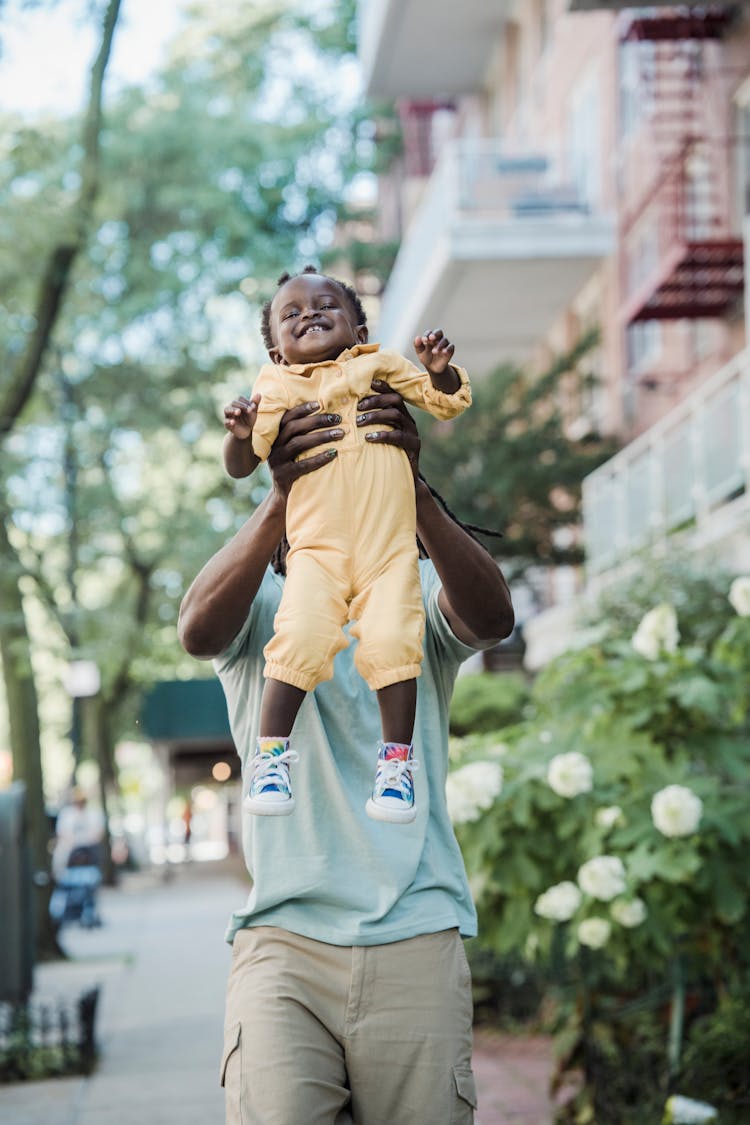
left=0, top=782, right=34, bottom=1004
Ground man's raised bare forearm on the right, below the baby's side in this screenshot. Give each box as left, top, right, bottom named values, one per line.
left=416, top=482, right=514, bottom=648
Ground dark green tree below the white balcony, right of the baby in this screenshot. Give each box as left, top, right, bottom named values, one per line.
left=421, top=334, right=614, bottom=577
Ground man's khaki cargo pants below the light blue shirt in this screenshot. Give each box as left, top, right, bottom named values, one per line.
left=222, top=926, right=477, bottom=1125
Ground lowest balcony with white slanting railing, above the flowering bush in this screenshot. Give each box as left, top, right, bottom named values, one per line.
left=584, top=351, right=750, bottom=586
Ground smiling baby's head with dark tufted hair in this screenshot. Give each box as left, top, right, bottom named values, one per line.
left=269, top=273, right=368, bottom=366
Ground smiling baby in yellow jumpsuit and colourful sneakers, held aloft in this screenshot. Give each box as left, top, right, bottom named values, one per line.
left=224, top=267, right=471, bottom=822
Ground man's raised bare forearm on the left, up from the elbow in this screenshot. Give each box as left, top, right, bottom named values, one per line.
left=178, top=493, right=284, bottom=659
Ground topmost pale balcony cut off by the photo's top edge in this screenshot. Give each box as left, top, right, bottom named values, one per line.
left=358, top=0, right=513, bottom=99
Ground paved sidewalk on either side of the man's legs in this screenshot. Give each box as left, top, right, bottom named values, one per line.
left=0, top=863, right=562, bottom=1125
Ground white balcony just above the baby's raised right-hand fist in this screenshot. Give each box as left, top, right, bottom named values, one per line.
left=377, top=140, right=614, bottom=375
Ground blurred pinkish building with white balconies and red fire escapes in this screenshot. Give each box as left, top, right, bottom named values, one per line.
left=360, top=0, right=750, bottom=665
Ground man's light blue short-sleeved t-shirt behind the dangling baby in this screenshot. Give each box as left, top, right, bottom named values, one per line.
left=214, top=560, right=477, bottom=945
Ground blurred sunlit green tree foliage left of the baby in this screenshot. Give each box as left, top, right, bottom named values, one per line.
left=0, top=0, right=368, bottom=918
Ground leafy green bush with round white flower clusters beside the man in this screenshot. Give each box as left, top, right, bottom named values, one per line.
left=449, top=579, right=750, bottom=1122
